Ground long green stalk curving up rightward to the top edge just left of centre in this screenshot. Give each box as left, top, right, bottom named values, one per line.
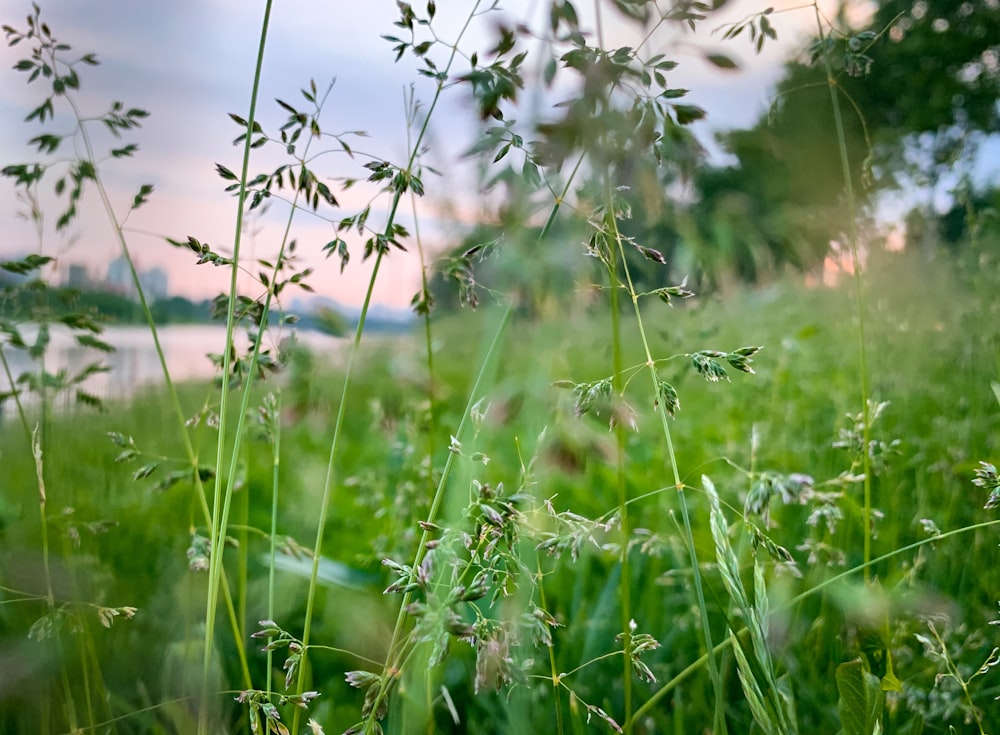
left=288, top=0, right=481, bottom=732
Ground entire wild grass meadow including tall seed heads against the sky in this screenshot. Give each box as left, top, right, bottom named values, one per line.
left=0, top=2, right=1000, bottom=735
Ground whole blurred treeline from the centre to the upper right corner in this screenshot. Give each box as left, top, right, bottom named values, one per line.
left=435, top=0, right=1000, bottom=310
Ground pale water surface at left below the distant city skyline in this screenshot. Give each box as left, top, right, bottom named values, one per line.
left=0, top=324, right=349, bottom=410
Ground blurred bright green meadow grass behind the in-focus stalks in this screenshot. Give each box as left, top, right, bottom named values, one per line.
left=0, top=246, right=998, bottom=732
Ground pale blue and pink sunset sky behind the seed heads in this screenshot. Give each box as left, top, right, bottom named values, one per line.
left=0, top=0, right=867, bottom=307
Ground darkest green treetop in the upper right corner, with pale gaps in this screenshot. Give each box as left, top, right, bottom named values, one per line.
left=842, top=0, right=1000, bottom=202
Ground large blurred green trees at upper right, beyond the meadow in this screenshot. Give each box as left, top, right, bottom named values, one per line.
left=664, top=0, right=1000, bottom=282
